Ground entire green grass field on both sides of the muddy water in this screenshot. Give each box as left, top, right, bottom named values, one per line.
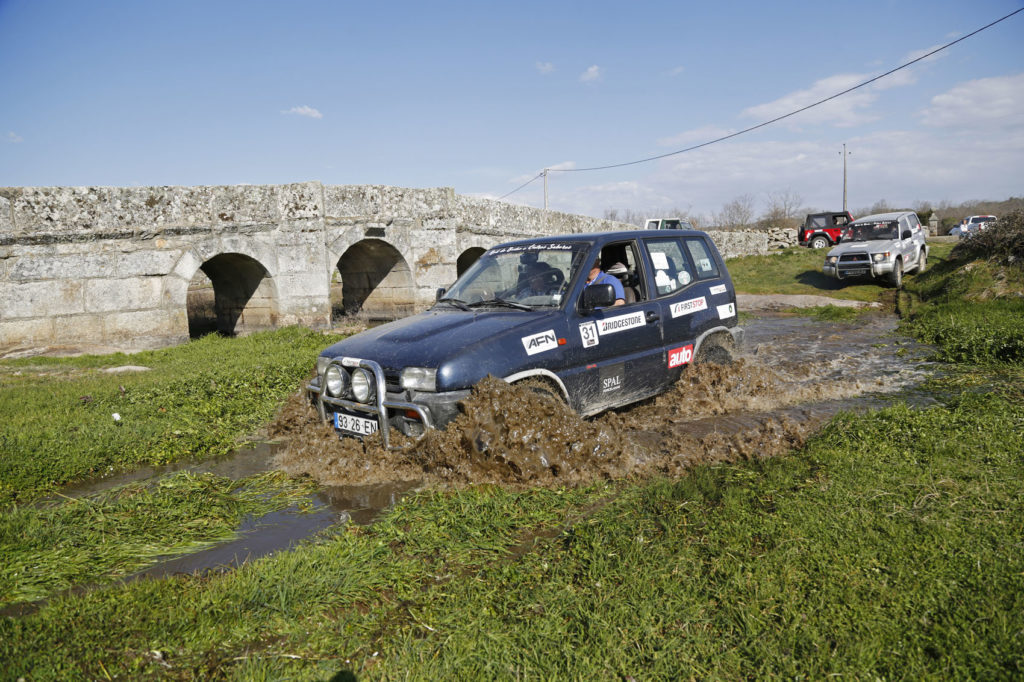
left=0, top=222, right=1024, bottom=680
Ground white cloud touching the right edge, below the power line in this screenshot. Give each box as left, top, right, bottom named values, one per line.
left=921, top=74, right=1024, bottom=131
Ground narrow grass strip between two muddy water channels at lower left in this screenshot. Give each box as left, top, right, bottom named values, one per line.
left=0, top=471, right=315, bottom=606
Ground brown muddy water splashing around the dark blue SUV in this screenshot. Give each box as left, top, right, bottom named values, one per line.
left=63, top=313, right=934, bottom=577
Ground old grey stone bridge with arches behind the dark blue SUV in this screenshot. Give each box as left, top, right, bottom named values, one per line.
left=0, top=182, right=782, bottom=355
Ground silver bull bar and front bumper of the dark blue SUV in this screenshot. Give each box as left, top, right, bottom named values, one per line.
left=306, top=357, right=470, bottom=447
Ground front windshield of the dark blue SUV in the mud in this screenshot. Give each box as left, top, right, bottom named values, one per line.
left=438, top=242, right=590, bottom=310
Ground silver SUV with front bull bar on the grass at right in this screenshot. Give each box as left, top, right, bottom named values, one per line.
left=822, top=211, right=928, bottom=288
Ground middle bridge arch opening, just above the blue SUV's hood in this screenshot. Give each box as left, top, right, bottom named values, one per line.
left=331, top=240, right=416, bottom=322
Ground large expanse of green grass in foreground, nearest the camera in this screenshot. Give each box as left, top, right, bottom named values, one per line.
left=0, top=385, right=1024, bottom=680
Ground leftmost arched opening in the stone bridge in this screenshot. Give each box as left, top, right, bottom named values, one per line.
left=187, top=253, right=278, bottom=338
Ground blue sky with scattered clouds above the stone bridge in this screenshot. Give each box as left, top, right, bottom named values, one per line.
left=0, top=0, right=1024, bottom=217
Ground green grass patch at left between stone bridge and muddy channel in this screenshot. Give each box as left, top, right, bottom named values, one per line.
left=0, top=327, right=330, bottom=506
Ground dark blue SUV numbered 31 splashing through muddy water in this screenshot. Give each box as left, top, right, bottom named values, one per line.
left=307, top=229, right=742, bottom=443
